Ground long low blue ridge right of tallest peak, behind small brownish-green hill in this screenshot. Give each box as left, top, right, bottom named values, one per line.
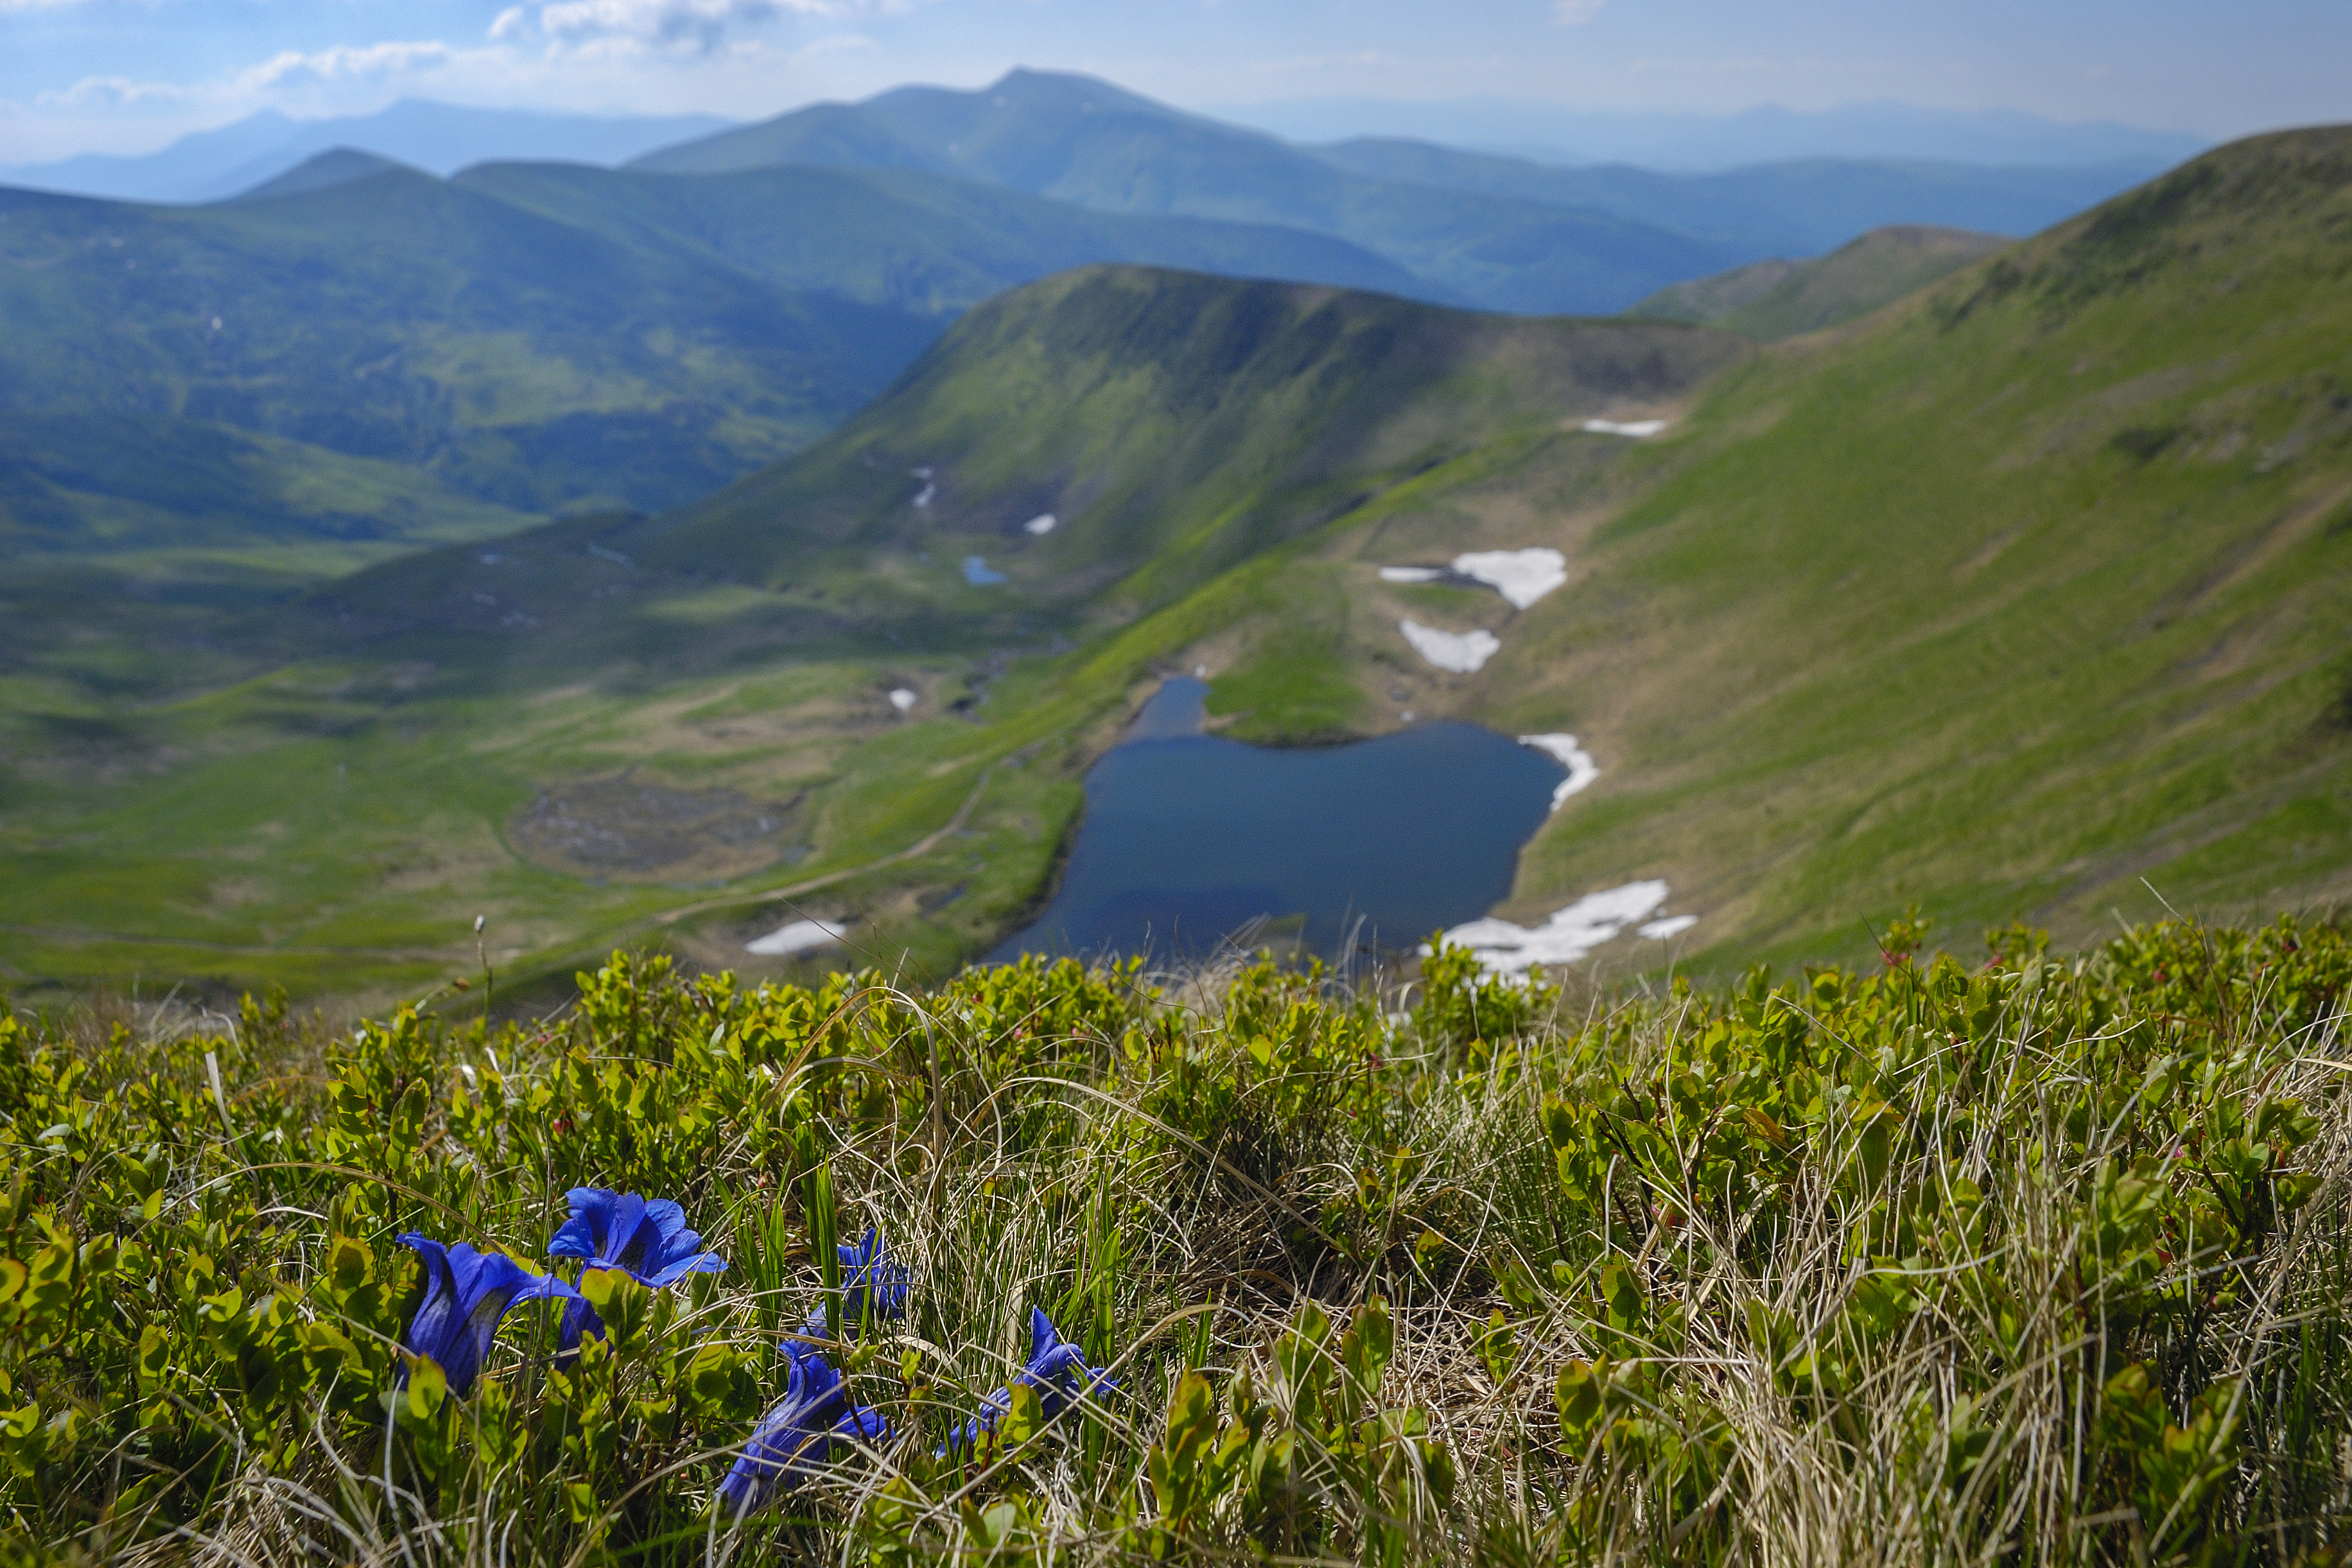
left=1315, top=136, right=2164, bottom=256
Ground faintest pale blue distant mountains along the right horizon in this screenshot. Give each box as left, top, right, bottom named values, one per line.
left=1214, top=99, right=2209, bottom=171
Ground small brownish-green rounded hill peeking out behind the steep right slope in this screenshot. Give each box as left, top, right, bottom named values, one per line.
left=1625, top=228, right=2008, bottom=338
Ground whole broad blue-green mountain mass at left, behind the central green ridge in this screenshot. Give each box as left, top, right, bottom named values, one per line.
left=0, top=153, right=1477, bottom=691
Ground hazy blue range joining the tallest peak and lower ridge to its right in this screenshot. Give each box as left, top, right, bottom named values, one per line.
left=632, top=71, right=2161, bottom=313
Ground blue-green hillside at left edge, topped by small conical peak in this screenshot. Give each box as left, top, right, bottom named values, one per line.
left=0, top=170, right=934, bottom=552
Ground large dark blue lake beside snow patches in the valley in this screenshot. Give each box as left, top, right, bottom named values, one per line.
left=990, top=679, right=1567, bottom=961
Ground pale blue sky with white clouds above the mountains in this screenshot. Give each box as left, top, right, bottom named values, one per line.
left=0, top=0, right=2352, bottom=162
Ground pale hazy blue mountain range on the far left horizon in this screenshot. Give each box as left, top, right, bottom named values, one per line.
left=0, top=99, right=729, bottom=202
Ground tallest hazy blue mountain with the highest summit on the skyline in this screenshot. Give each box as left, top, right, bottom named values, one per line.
left=632, top=71, right=1741, bottom=313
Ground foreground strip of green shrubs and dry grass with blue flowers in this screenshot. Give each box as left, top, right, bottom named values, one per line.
left=0, top=919, right=2352, bottom=1568
